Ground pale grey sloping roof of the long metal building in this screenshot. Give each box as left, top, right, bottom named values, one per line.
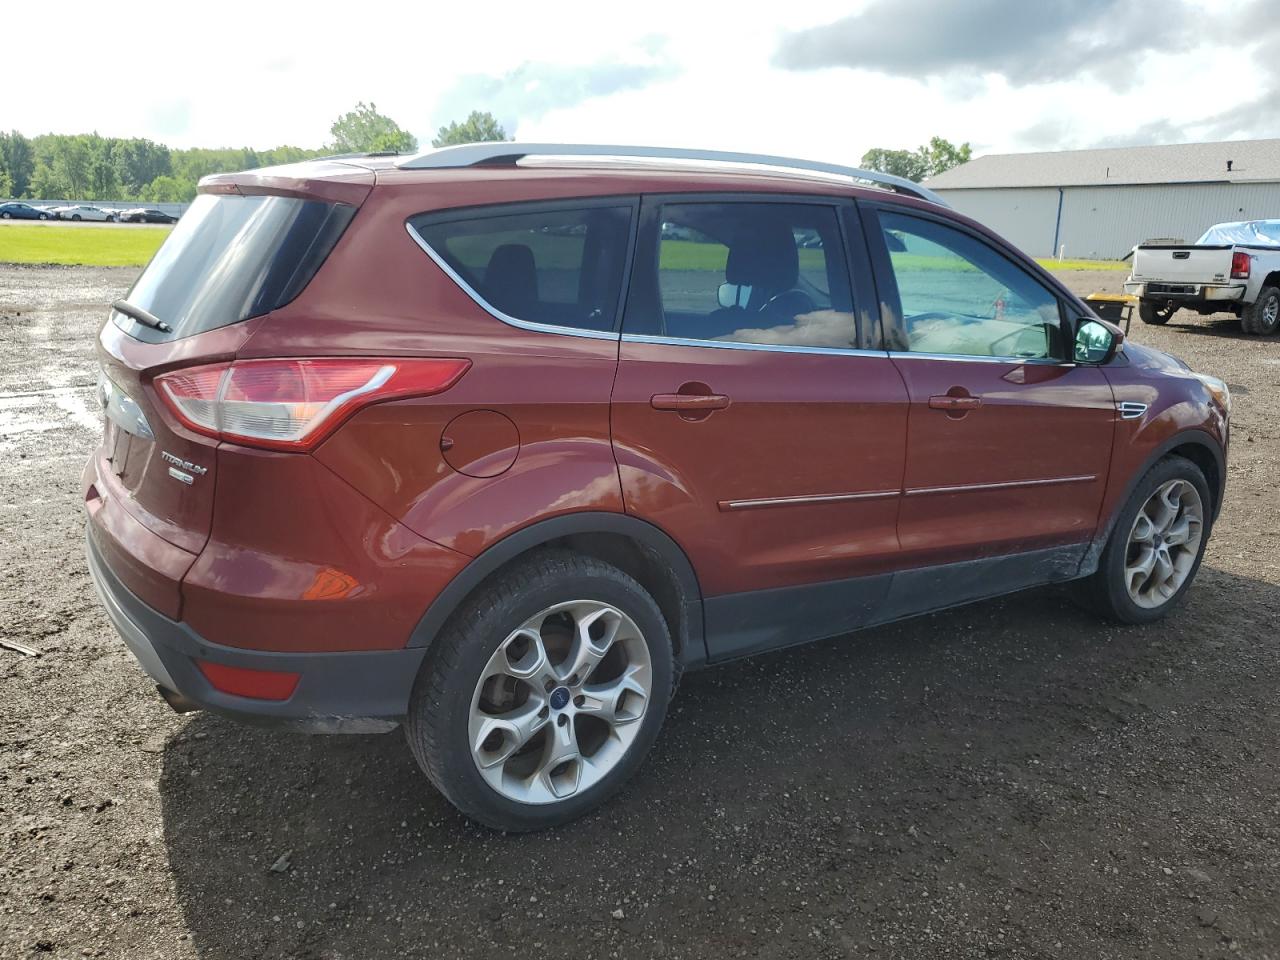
left=925, top=140, right=1280, bottom=191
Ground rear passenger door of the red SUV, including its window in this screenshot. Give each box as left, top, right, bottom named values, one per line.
left=613, top=195, right=906, bottom=659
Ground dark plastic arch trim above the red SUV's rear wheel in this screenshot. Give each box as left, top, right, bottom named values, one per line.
left=408, top=511, right=707, bottom=668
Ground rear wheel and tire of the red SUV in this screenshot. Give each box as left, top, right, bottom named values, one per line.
left=404, top=550, right=675, bottom=832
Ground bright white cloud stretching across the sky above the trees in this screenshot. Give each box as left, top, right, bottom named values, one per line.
left=0, top=0, right=1267, bottom=163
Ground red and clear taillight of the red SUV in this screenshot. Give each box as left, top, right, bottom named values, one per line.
left=155, top=357, right=471, bottom=451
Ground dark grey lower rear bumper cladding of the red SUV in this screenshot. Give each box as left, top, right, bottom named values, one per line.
left=87, top=536, right=426, bottom=733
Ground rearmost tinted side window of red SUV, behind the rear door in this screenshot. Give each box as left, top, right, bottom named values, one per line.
left=410, top=205, right=632, bottom=330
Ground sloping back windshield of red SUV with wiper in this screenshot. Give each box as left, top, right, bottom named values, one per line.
left=111, top=193, right=356, bottom=343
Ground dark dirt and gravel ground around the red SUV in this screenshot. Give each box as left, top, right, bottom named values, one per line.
left=0, top=268, right=1280, bottom=960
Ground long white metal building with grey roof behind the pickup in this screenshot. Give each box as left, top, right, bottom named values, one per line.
left=925, top=140, right=1280, bottom=260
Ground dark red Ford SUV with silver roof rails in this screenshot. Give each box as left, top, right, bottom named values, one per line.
left=84, top=143, right=1230, bottom=831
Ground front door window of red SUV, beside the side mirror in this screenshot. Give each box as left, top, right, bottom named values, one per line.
left=879, top=211, right=1065, bottom=360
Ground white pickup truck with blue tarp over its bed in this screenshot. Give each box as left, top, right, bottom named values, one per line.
left=1124, top=220, right=1280, bottom=337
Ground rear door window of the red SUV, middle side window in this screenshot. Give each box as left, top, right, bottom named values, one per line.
left=658, top=201, right=858, bottom=349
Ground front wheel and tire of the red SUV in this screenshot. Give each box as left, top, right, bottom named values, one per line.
left=1076, top=456, right=1212, bottom=623
